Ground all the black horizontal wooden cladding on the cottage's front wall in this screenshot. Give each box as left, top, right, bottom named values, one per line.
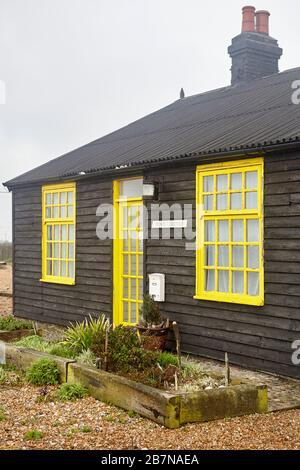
left=14, top=153, right=300, bottom=377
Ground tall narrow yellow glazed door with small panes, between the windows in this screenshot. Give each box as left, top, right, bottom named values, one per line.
left=114, top=178, right=143, bottom=325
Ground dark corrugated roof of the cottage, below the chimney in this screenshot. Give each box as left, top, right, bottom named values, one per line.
left=7, top=68, right=300, bottom=187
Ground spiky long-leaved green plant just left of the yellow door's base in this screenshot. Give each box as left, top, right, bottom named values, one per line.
left=64, top=315, right=109, bottom=355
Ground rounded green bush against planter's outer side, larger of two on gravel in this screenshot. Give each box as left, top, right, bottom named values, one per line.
left=26, top=359, right=59, bottom=385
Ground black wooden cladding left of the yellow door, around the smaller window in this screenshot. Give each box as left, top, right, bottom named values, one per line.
left=14, top=181, right=112, bottom=325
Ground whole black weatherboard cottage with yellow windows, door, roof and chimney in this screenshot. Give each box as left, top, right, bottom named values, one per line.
left=6, top=7, right=300, bottom=377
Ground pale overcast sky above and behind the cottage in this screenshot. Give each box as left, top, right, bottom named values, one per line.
left=0, top=0, right=300, bottom=240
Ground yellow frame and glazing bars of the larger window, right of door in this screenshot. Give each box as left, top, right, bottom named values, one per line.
left=195, top=158, right=264, bottom=306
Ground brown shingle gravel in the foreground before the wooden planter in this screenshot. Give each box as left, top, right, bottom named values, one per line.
left=0, top=386, right=300, bottom=450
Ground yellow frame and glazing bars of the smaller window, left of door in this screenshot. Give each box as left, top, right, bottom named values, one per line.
left=40, top=183, right=76, bottom=285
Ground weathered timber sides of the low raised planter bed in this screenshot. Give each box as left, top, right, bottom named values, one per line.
left=2, top=344, right=268, bottom=429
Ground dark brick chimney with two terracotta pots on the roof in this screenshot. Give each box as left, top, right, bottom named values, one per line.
left=228, top=6, right=283, bottom=85
